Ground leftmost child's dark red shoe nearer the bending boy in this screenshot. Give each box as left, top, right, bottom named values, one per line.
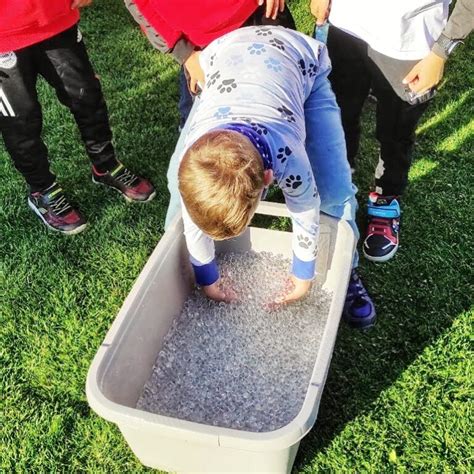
left=92, top=163, right=156, bottom=202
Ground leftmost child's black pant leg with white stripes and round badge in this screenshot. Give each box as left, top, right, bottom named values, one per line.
left=0, top=46, right=55, bottom=192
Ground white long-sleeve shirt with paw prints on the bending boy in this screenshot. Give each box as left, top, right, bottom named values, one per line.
left=180, top=26, right=330, bottom=284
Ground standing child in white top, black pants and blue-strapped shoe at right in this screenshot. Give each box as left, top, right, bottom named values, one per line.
left=311, top=0, right=474, bottom=262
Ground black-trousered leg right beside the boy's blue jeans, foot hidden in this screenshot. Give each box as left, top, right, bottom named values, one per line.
left=328, top=26, right=371, bottom=167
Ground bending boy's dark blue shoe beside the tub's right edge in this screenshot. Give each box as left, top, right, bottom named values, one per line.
left=342, top=270, right=377, bottom=329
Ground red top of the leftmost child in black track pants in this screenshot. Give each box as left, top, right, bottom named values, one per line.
left=0, top=0, right=79, bottom=53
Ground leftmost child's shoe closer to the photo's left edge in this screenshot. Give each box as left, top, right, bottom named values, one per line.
left=28, top=183, right=87, bottom=235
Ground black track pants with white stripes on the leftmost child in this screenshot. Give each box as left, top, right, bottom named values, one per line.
left=0, top=26, right=116, bottom=192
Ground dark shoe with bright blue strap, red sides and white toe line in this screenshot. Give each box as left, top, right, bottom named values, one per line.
left=363, top=193, right=400, bottom=262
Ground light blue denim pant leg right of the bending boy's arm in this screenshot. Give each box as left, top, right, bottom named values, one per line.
left=304, top=71, right=359, bottom=268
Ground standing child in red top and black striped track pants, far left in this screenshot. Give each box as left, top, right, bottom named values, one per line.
left=0, top=0, right=155, bottom=234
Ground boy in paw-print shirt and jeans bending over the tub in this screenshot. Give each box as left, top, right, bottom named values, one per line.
left=167, top=27, right=375, bottom=327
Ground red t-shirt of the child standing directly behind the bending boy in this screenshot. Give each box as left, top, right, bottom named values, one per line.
left=134, top=0, right=258, bottom=48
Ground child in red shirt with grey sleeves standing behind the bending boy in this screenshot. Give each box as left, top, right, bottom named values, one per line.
left=125, top=0, right=295, bottom=128
